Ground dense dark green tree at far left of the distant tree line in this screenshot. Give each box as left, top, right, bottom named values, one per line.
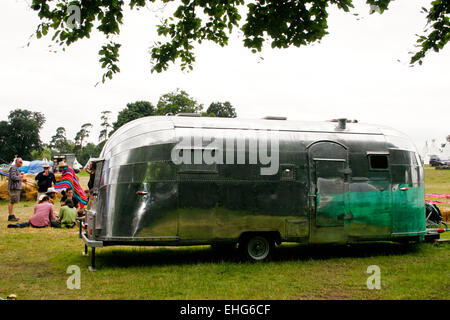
left=0, top=109, right=45, bottom=163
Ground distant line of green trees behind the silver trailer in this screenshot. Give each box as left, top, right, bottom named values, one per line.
left=0, top=89, right=237, bottom=164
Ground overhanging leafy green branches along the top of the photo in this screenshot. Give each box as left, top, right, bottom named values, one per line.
left=31, top=0, right=450, bottom=81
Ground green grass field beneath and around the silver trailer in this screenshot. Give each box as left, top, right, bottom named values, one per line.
left=0, top=169, right=450, bottom=299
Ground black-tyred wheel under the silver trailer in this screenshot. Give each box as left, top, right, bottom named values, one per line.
left=239, top=235, right=274, bottom=262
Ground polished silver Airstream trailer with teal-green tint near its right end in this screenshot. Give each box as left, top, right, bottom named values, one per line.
left=81, top=116, right=426, bottom=264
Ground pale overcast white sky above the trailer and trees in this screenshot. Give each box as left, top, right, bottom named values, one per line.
left=0, top=0, right=450, bottom=155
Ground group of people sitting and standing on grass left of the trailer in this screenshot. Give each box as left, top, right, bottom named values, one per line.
left=4, top=158, right=95, bottom=228
